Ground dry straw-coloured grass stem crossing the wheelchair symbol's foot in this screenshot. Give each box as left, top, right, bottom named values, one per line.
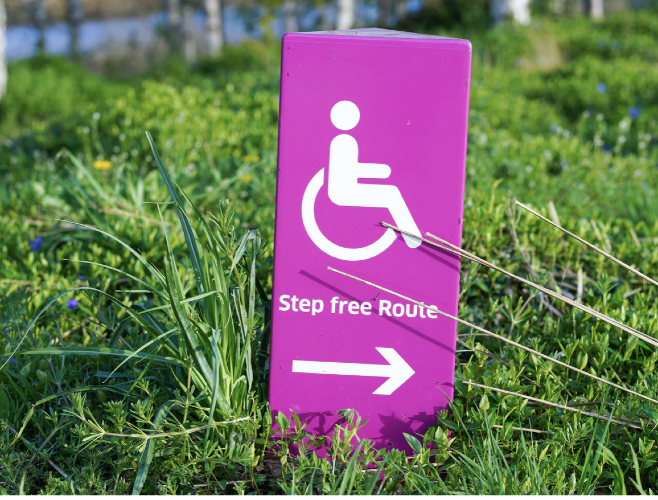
left=382, top=222, right=658, bottom=347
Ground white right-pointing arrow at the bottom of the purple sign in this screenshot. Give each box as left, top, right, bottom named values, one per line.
left=292, top=347, right=414, bottom=396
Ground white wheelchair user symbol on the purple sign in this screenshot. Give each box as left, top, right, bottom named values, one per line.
left=302, top=101, right=422, bottom=261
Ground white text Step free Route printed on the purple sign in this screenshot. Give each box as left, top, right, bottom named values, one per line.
left=279, top=295, right=438, bottom=319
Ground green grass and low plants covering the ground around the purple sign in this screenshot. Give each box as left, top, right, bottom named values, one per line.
left=0, top=7, right=658, bottom=494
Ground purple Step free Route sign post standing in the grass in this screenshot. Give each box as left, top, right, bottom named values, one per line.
left=270, top=29, right=471, bottom=449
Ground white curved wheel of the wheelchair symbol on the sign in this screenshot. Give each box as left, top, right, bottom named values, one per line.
left=302, top=168, right=396, bottom=261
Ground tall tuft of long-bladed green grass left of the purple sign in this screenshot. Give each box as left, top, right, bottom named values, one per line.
left=4, top=136, right=269, bottom=493
